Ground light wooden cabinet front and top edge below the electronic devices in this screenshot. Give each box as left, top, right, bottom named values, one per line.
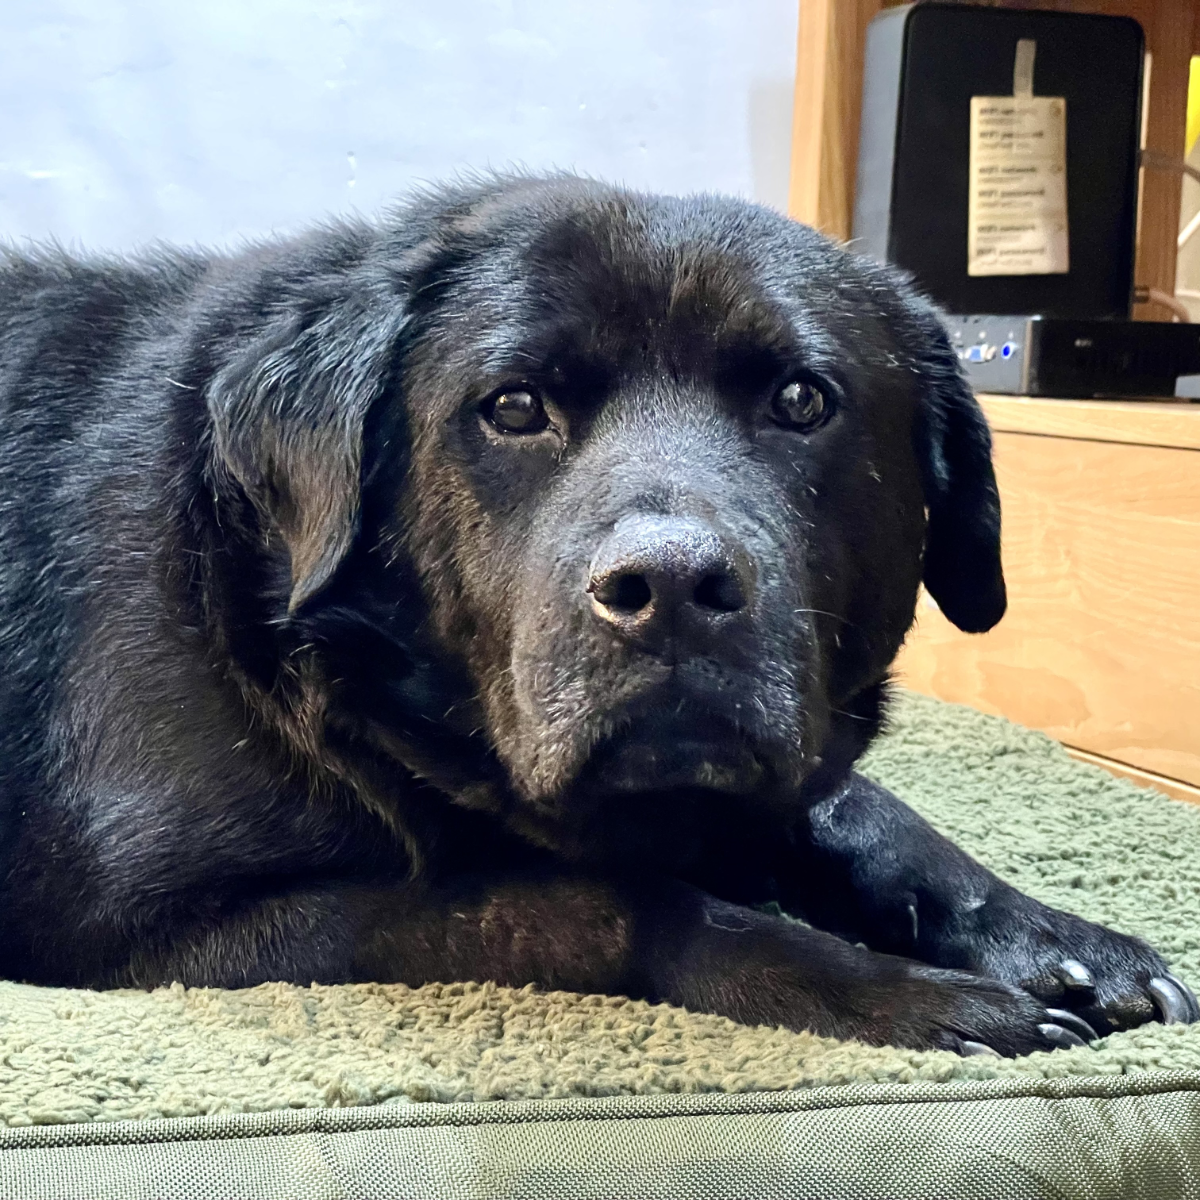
left=898, top=396, right=1200, bottom=800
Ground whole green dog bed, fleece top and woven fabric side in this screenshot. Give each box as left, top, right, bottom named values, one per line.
left=0, top=695, right=1200, bottom=1198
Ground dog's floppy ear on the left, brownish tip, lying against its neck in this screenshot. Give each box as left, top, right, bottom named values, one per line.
left=208, top=288, right=403, bottom=612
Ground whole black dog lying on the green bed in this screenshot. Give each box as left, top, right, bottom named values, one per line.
left=0, top=178, right=1200, bottom=1054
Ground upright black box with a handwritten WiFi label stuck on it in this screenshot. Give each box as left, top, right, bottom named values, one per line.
left=853, top=2, right=1145, bottom=318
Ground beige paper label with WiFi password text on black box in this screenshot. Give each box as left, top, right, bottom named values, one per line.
left=967, top=93, right=1070, bottom=275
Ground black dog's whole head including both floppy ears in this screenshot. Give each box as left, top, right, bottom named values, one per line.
left=210, top=178, right=1004, bottom=853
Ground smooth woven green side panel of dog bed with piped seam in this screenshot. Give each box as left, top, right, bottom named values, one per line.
left=0, top=1073, right=1200, bottom=1200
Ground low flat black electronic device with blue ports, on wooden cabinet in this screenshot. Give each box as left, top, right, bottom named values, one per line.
left=946, top=314, right=1200, bottom=400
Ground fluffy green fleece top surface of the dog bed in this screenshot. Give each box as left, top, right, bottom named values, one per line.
left=0, top=695, right=1200, bottom=1126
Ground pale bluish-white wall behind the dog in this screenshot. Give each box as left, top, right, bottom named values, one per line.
left=0, top=0, right=797, bottom=248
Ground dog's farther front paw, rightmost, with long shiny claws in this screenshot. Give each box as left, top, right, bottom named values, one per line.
left=949, top=892, right=1200, bottom=1037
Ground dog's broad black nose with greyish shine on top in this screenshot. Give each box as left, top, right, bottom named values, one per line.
left=588, top=516, right=754, bottom=637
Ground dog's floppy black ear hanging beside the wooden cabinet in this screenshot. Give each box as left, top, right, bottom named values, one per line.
left=916, top=305, right=1008, bottom=634
